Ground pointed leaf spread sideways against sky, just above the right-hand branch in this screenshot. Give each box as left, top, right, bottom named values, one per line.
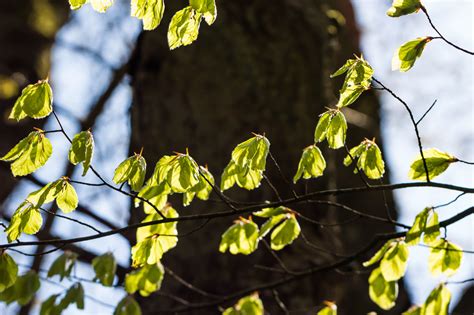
left=408, top=148, right=458, bottom=180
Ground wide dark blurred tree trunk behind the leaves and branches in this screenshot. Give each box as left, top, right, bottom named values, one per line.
left=131, top=0, right=409, bottom=314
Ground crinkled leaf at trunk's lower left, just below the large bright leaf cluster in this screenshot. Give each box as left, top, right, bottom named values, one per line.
left=125, top=262, right=165, bottom=297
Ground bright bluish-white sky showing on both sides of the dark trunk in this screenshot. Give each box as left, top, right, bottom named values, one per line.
left=0, top=0, right=474, bottom=314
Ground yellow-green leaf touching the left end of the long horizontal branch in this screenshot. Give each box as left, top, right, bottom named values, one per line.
left=5, top=201, right=43, bottom=243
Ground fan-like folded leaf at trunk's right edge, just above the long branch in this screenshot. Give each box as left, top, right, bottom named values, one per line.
left=344, top=139, right=385, bottom=179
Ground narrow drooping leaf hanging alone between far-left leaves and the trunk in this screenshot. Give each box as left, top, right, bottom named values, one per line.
left=69, top=130, right=94, bottom=176
